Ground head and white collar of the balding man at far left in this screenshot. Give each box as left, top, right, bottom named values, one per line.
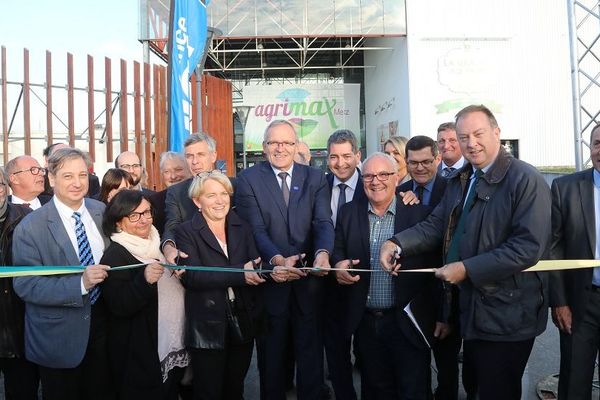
left=6, top=156, right=50, bottom=210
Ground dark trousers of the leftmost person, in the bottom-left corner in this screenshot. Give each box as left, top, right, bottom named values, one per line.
left=0, top=358, right=40, bottom=400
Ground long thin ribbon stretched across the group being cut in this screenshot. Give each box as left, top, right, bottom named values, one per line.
left=0, top=260, right=600, bottom=278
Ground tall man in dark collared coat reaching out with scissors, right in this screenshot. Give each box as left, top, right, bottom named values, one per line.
left=380, top=105, right=551, bottom=400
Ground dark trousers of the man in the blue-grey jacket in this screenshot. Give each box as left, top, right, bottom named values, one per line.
left=39, top=302, right=116, bottom=400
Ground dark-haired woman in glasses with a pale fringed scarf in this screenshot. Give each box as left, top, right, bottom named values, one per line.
left=100, top=190, right=188, bottom=400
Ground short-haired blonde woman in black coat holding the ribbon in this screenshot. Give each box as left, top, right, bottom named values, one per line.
left=175, top=171, right=265, bottom=400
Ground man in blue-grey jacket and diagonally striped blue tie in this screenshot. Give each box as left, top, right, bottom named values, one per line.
left=13, top=148, right=113, bottom=400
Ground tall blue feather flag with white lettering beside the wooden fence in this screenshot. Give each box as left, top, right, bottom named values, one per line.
left=169, top=0, right=209, bottom=152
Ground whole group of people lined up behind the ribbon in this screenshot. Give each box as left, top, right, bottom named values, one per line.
left=0, top=105, right=600, bottom=400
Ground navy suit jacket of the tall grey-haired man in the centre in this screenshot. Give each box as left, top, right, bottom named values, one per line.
left=235, top=162, right=334, bottom=315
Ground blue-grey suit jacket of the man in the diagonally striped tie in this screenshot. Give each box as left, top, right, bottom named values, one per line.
left=12, top=198, right=108, bottom=368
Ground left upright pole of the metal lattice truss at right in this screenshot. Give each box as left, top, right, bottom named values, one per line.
left=567, top=0, right=583, bottom=171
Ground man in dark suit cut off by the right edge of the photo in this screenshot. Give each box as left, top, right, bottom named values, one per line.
left=550, top=125, right=600, bottom=400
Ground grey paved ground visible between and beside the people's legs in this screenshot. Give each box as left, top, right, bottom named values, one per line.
left=0, top=310, right=559, bottom=400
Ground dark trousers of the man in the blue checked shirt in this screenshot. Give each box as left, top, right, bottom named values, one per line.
left=357, top=310, right=431, bottom=400
